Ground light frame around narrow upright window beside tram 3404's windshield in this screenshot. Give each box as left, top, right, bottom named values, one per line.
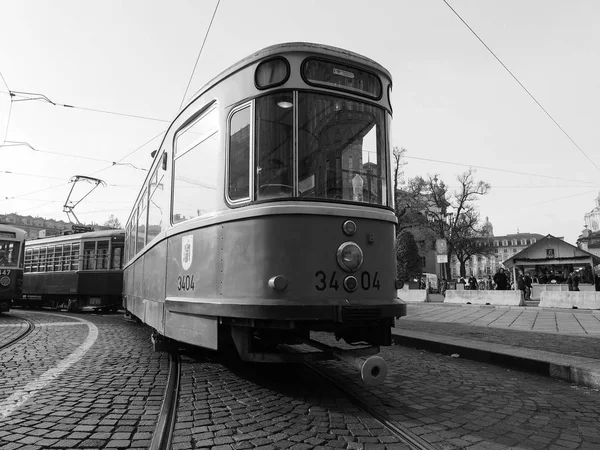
left=225, top=101, right=254, bottom=205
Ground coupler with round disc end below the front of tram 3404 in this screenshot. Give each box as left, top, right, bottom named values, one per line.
left=303, top=339, right=387, bottom=386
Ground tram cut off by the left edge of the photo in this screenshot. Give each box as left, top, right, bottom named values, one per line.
left=0, top=224, right=27, bottom=313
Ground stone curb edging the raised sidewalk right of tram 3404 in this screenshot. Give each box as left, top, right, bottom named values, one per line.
left=392, top=328, right=600, bottom=389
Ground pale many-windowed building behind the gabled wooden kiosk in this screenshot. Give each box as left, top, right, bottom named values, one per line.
left=449, top=217, right=548, bottom=278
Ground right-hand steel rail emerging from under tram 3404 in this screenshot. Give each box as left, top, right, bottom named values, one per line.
left=304, top=363, right=438, bottom=450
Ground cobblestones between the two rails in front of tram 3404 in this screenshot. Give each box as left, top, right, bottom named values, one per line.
left=173, top=356, right=409, bottom=450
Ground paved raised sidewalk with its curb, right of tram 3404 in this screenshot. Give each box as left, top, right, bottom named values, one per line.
left=392, top=303, right=600, bottom=388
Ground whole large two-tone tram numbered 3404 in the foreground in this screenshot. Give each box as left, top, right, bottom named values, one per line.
left=123, top=43, right=406, bottom=384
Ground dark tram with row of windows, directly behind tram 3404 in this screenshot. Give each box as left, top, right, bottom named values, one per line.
left=14, top=230, right=125, bottom=312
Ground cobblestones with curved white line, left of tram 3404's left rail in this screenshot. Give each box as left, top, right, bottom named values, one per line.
left=0, top=310, right=169, bottom=450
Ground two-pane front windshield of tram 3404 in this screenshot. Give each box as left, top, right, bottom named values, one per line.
left=256, top=92, right=387, bottom=205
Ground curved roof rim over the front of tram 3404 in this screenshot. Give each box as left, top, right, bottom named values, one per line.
left=181, top=42, right=392, bottom=111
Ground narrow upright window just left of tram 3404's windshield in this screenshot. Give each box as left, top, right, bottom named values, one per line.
left=229, top=106, right=250, bottom=201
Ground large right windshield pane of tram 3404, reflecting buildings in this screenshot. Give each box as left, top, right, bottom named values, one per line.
left=298, top=93, right=387, bottom=205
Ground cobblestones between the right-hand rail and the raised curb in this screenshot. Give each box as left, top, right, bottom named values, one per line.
left=312, top=332, right=600, bottom=450
